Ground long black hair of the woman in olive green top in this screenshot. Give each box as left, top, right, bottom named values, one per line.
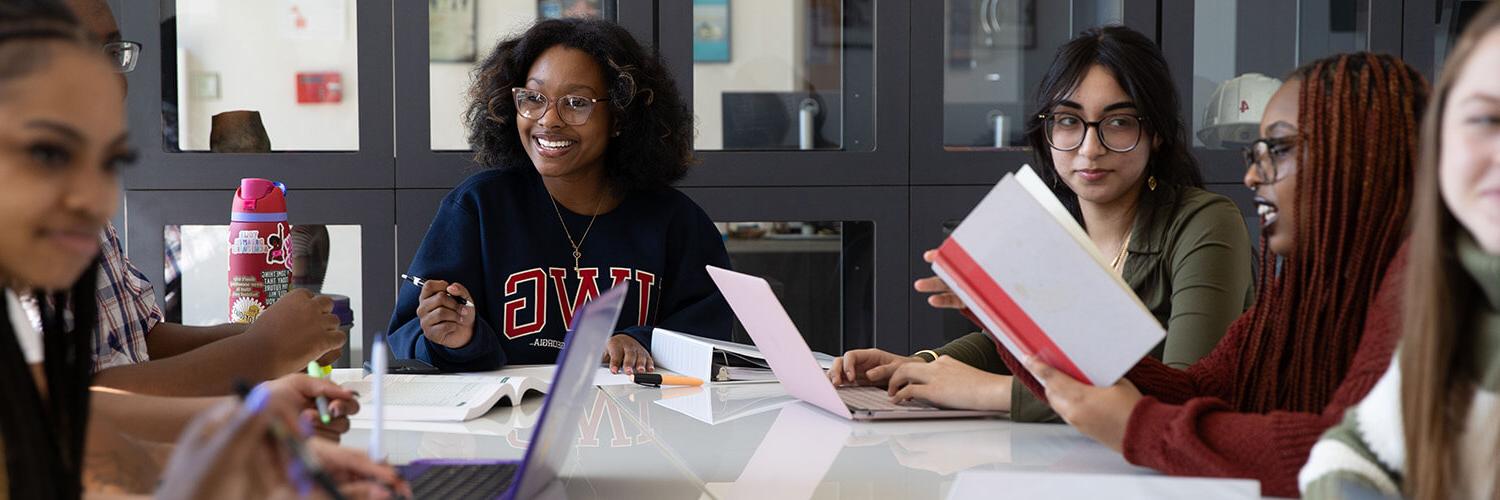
left=1026, top=26, right=1203, bottom=224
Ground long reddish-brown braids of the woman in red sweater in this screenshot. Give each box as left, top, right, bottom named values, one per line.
left=1233, top=53, right=1428, bottom=411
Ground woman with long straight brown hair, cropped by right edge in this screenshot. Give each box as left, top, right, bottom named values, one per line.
left=1299, top=3, right=1500, bottom=498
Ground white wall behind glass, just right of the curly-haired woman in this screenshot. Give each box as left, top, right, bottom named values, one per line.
left=693, top=0, right=807, bottom=150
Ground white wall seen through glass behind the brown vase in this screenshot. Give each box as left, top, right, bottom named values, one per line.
left=177, top=0, right=360, bottom=152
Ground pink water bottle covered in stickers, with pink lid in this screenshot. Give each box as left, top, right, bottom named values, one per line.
left=230, top=179, right=291, bottom=323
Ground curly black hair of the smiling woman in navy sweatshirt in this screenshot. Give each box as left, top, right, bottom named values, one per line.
left=464, top=18, right=693, bottom=192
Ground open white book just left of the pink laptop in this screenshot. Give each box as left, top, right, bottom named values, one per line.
left=651, top=329, right=834, bottom=383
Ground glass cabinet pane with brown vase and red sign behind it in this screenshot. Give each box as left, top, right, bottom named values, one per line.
left=156, top=0, right=362, bottom=153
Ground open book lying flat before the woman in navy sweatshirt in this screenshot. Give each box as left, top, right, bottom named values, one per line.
left=341, top=365, right=630, bottom=422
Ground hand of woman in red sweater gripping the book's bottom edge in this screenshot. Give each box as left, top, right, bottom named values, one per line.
left=1026, top=357, right=1142, bottom=452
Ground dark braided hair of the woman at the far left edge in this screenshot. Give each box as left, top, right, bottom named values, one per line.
left=0, top=0, right=102, bottom=498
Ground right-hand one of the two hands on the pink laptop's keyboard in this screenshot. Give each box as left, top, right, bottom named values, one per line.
left=887, top=356, right=1011, bottom=411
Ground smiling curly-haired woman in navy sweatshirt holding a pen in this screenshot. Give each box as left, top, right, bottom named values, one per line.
left=390, top=20, right=734, bottom=372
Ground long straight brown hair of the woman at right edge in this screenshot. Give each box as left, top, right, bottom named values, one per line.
left=1397, top=3, right=1500, bottom=498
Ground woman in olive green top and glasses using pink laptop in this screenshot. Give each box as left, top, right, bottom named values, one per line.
left=830, top=26, right=1253, bottom=422
